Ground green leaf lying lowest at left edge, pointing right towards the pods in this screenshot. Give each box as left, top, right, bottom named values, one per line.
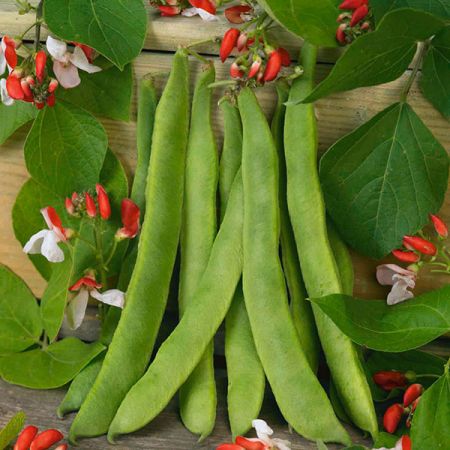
left=0, top=337, right=105, bottom=389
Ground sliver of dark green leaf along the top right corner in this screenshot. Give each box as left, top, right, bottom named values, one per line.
left=370, top=0, right=450, bottom=23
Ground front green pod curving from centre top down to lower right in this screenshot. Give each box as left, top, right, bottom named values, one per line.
left=238, top=88, right=350, bottom=444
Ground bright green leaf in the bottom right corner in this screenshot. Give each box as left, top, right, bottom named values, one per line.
left=411, top=363, right=450, bottom=450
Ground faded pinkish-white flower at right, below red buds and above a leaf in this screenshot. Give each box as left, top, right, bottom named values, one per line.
left=377, top=264, right=417, bottom=305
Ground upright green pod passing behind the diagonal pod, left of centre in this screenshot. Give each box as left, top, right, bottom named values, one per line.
left=178, top=63, right=219, bottom=440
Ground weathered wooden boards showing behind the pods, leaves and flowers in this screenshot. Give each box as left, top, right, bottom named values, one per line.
left=0, top=0, right=450, bottom=450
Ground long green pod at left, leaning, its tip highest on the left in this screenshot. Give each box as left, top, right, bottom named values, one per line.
left=69, top=49, right=189, bottom=442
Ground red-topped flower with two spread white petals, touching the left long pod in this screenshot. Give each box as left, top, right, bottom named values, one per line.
left=66, top=276, right=125, bottom=330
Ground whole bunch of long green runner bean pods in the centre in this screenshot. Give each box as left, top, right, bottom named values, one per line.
left=64, top=44, right=378, bottom=445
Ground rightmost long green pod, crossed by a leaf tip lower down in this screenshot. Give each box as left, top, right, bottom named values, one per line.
left=284, top=43, right=378, bottom=436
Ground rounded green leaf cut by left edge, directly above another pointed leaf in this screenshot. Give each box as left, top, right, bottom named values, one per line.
left=0, top=265, right=42, bottom=354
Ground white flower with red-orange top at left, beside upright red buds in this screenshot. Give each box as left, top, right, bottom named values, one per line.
left=23, top=206, right=67, bottom=262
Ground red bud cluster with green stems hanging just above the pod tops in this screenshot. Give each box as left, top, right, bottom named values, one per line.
left=220, top=28, right=291, bottom=84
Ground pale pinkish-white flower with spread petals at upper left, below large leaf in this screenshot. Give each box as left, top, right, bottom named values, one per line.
left=47, top=36, right=102, bottom=89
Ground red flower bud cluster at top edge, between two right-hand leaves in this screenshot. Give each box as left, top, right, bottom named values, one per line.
left=336, top=0, right=371, bottom=45
